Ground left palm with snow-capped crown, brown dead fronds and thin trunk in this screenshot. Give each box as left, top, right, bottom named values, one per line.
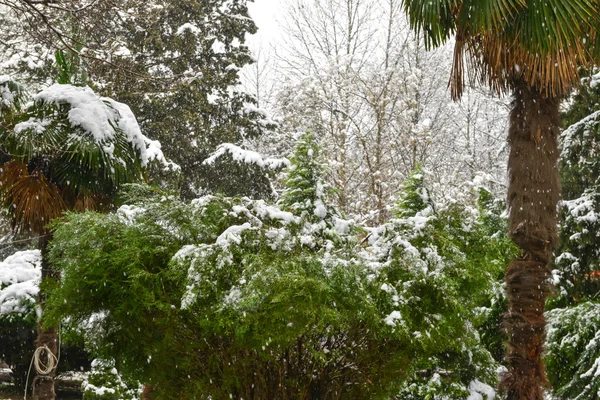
left=0, top=76, right=167, bottom=399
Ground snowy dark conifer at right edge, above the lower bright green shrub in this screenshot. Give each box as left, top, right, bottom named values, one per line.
left=554, top=70, right=600, bottom=306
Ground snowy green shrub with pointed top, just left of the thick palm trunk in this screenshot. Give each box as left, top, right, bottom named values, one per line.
left=370, top=170, right=513, bottom=399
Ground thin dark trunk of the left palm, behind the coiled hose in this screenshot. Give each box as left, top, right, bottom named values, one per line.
left=33, top=236, right=58, bottom=400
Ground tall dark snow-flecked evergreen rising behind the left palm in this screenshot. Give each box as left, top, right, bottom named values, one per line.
left=90, top=0, right=274, bottom=198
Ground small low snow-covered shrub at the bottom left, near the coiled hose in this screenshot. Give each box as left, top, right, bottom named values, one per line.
left=81, top=359, right=142, bottom=400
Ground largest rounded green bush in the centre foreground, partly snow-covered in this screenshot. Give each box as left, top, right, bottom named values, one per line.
left=47, top=189, right=409, bottom=399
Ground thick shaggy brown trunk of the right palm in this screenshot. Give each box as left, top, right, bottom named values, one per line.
left=501, top=83, right=561, bottom=400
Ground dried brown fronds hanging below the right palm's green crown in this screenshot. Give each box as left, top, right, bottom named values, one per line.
left=449, top=0, right=600, bottom=99
